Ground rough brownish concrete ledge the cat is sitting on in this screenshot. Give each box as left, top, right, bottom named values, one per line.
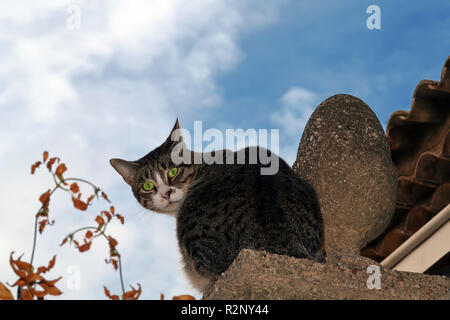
left=203, top=249, right=450, bottom=300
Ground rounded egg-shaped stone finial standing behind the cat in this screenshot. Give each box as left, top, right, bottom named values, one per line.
left=293, top=94, right=397, bottom=254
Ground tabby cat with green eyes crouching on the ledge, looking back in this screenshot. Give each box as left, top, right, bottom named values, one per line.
left=110, top=119, right=324, bottom=292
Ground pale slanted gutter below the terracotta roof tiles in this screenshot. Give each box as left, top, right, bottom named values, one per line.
left=381, top=204, right=450, bottom=272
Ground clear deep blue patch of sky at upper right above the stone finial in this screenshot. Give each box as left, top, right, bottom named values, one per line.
left=214, top=1, right=450, bottom=139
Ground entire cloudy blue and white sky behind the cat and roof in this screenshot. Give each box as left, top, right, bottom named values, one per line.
left=0, top=0, right=450, bottom=299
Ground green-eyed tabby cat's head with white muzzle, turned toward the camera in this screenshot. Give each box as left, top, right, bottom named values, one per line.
left=110, top=119, right=195, bottom=216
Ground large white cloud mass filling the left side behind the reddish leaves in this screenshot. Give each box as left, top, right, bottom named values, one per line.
left=0, top=0, right=280, bottom=299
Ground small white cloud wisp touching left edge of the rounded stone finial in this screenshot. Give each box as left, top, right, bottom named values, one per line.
left=270, top=86, right=318, bottom=164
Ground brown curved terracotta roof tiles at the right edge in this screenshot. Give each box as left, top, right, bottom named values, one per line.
left=361, top=57, right=450, bottom=261
